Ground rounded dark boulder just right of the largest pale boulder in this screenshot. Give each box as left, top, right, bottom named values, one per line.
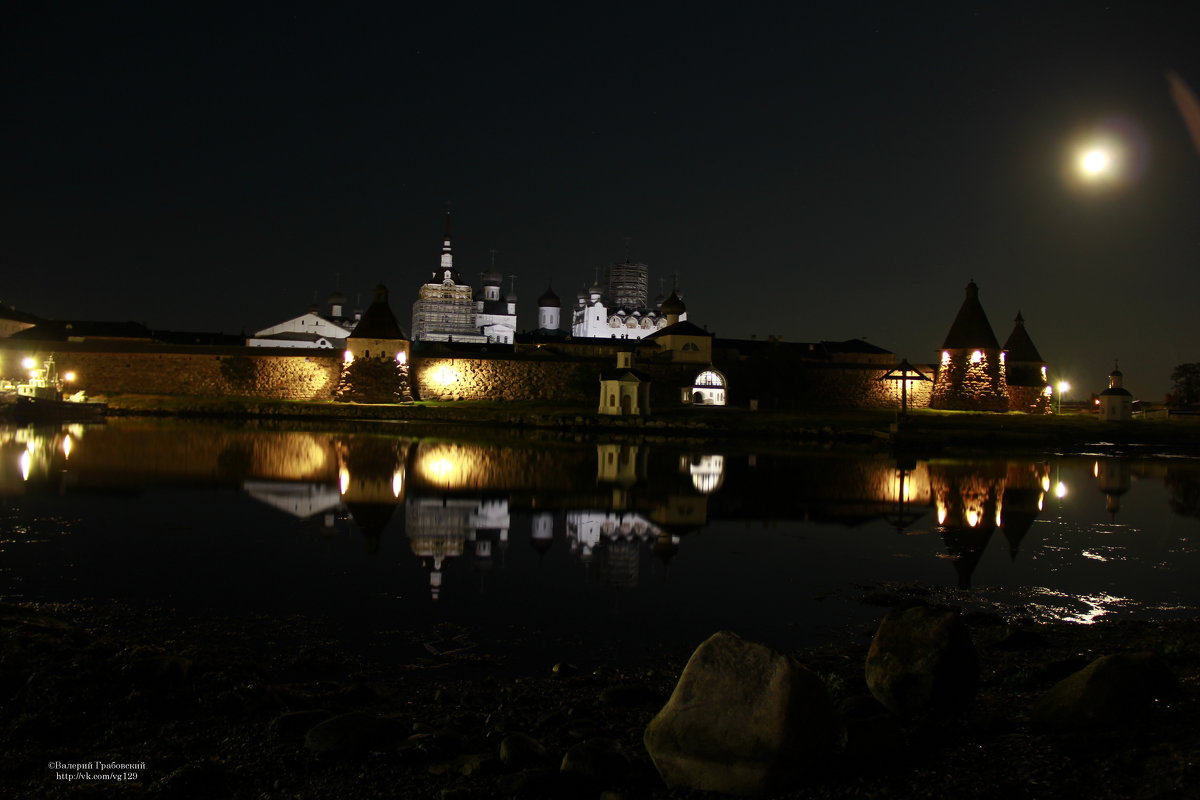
left=866, top=606, right=979, bottom=716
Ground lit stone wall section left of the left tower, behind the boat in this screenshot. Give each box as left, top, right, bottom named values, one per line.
left=0, top=342, right=342, bottom=401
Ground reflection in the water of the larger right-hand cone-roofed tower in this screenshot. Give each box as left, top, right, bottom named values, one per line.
left=929, top=463, right=1006, bottom=589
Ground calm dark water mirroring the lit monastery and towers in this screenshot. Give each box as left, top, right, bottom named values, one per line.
left=0, top=420, right=1200, bottom=661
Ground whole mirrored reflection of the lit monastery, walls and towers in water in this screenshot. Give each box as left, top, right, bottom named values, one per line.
left=7, top=421, right=1200, bottom=599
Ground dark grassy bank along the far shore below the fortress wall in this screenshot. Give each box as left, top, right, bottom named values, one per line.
left=93, top=395, right=1200, bottom=456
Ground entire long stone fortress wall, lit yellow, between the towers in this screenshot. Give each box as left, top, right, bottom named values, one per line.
left=0, top=339, right=931, bottom=410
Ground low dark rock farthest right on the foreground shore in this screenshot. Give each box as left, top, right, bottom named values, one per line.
left=1031, top=652, right=1178, bottom=730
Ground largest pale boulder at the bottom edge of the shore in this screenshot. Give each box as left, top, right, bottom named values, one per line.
left=644, top=631, right=840, bottom=795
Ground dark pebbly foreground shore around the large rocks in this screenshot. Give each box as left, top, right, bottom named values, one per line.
left=0, top=590, right=1200, bottom=800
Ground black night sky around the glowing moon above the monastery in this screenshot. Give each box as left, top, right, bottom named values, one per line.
left=0, top=1, right=1200, bottom=401
